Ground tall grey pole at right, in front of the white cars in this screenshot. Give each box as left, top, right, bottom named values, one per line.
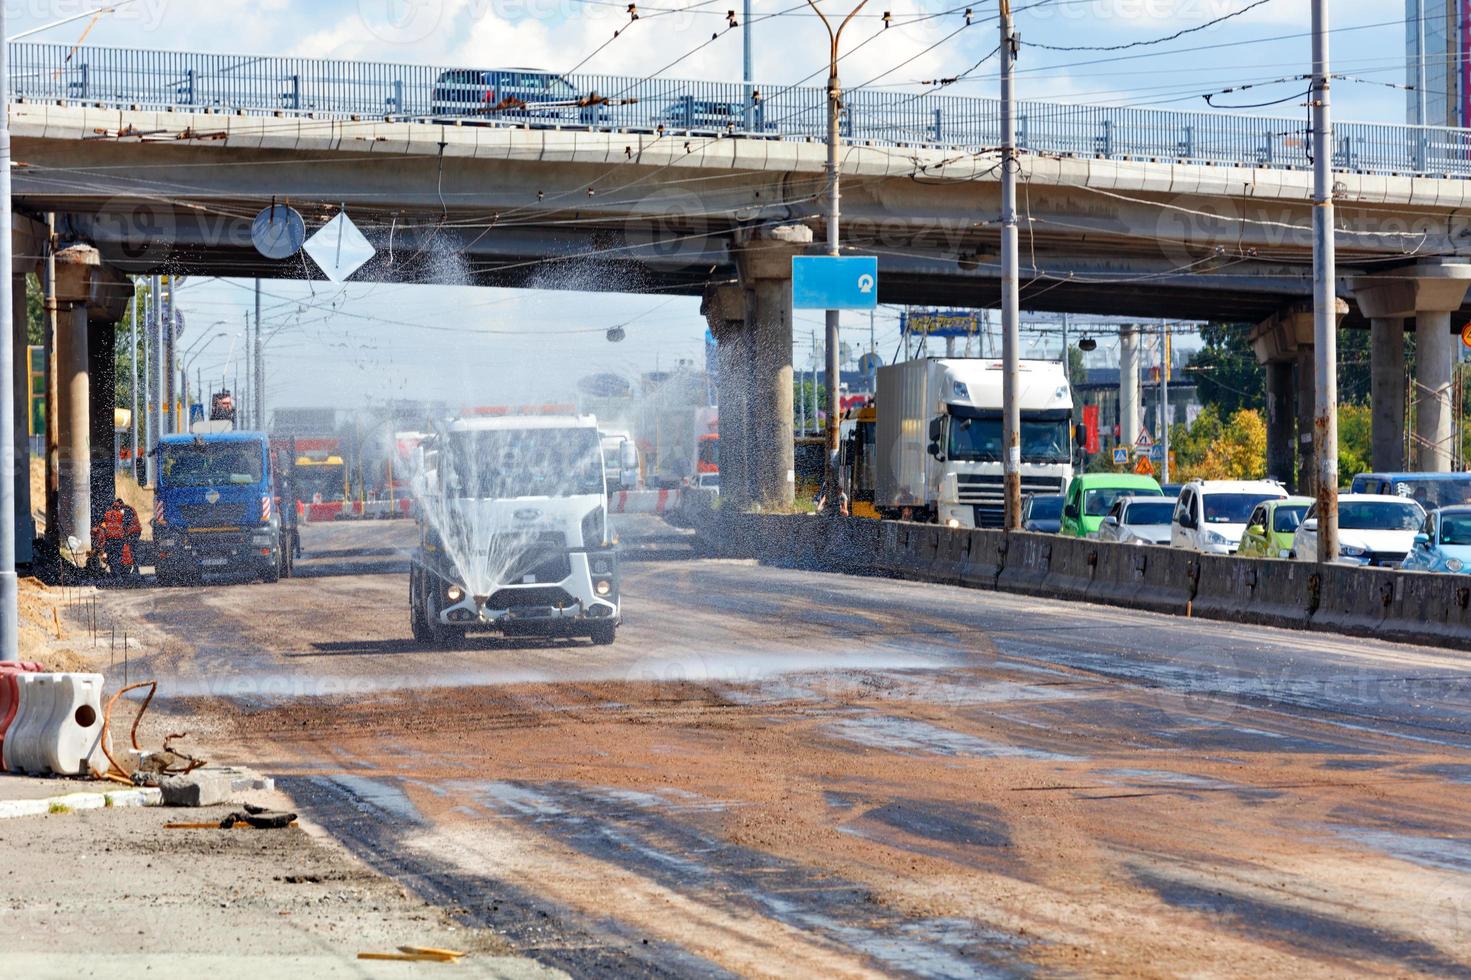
left=1312, top=0, right=1339, bottom=562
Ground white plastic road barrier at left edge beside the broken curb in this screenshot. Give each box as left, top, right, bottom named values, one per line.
left=4, top=674, right=106, bottom=775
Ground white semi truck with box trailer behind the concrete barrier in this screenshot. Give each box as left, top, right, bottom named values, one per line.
left=874, top=358, right=1072, bottom=527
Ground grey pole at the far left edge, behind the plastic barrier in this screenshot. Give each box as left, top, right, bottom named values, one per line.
left=0, top=3, right=16, bottom=661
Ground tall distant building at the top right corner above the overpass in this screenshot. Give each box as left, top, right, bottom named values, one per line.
left=1405, top=0, right=1471, bottom=127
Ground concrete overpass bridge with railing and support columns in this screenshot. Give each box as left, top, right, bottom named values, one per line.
left=10, top=44, right=1471, bottom=553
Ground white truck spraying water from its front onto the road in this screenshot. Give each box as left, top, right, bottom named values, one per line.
left=409, top=415, right=621, bottom=645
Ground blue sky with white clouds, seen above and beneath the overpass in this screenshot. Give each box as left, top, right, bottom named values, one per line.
left=6, top=0, right=1406, bottom=406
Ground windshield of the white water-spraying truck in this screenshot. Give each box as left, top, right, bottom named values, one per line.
left=440, top=428, right=603, bottom=499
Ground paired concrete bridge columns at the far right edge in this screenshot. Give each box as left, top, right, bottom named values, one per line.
left=1353, top=259, right=1471, bottom=471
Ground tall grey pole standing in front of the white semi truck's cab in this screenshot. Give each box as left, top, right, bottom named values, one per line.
left=1000, top=0, right=1021, bottom=531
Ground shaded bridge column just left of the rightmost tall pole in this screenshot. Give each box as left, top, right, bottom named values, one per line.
left=1250, top=300, right=1349, bottom=494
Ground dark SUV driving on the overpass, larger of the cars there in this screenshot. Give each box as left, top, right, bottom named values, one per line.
left=430, top=68, right=608, bottom=127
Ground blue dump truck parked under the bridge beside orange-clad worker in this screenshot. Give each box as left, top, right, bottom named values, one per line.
left=153, top=431, right=297, bottom=586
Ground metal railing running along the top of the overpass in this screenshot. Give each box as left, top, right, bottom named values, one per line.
left=10, top=43, right=1471, bottom=177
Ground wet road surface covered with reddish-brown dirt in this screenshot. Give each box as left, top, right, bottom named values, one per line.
left=60, top=518, right=1471, bottom=977
